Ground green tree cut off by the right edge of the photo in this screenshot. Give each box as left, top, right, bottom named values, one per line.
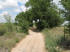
left=61, top=0, right=70, bottom=34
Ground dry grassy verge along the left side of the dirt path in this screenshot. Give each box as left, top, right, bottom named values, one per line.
left=0, top=32, right=26, bottom=52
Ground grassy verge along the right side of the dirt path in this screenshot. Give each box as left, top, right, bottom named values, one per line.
left=43, top=27, right=63, bottom=52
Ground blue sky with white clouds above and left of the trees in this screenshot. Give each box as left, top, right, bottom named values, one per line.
left=0, top=0, right=60, bottom=23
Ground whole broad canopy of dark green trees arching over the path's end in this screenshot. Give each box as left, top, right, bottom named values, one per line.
left=16, top=0, right=62, bottom=30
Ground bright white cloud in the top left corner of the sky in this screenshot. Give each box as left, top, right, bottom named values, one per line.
left=0, top=0, right=18, bottom=7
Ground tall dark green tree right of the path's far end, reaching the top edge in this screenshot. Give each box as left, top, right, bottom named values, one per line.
left=26, top=0, right=62, bottom=29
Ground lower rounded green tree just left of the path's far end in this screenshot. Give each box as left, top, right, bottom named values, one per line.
left=15, top=12, right=31, bottom=33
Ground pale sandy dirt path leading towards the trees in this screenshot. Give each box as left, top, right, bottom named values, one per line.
left=11, top=30, right=46, bottom=52
